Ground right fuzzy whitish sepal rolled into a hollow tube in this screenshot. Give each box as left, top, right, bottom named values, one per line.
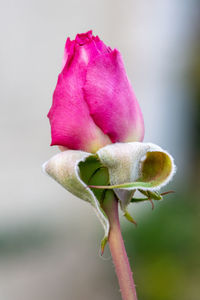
left=96, top=142, right=175, bottom=211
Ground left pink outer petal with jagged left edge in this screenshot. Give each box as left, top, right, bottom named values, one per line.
left=48, top=40, right=110, bottom=152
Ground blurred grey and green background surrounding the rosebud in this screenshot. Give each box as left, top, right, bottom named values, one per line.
left=0, top=0, right=200, bottom=300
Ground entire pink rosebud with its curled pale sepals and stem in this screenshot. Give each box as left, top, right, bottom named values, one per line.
left=43, top=31, right=176, bottom=276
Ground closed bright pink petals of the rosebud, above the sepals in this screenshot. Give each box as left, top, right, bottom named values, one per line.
left=48, top=31, right=144, bottom=153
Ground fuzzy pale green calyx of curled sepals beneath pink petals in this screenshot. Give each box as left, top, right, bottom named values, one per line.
left=43, top=142, right=176, bottom=252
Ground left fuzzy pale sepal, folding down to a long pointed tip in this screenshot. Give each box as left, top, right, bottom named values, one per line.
left=43, top=150, right=109, bottom=248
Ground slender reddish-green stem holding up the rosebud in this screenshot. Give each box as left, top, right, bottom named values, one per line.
left=103, top=194, right=137, bottom=300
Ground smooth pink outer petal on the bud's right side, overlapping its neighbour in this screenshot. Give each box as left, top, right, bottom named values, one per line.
left=84, top=50, right=144, bottom=143
